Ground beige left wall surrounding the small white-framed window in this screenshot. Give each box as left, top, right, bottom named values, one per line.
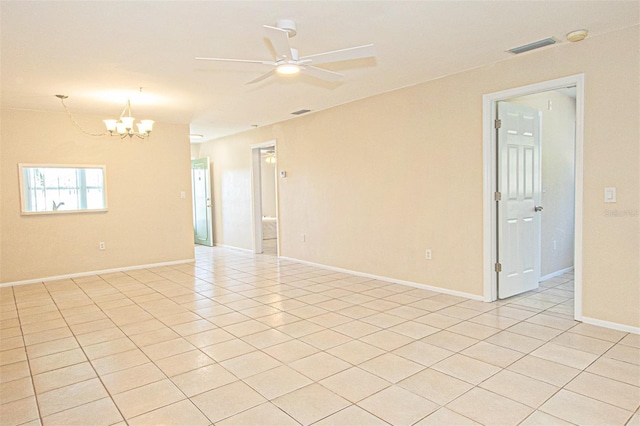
left=0, top=110, right=194, bottom=283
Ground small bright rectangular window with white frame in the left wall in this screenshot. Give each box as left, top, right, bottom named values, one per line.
left=18, top=164, right=107, bottom=214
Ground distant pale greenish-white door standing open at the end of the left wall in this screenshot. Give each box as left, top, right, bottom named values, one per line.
left=191, top=158, right=213, bottom=246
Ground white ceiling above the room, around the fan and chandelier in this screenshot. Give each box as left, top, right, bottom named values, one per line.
left=0, top=0, right=640, bottom=140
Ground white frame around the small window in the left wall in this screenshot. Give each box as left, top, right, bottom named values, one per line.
left=18, top=163, right=108, bottom=216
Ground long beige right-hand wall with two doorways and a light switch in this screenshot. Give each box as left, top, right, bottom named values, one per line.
left=201, top=26, right=640, bottom=327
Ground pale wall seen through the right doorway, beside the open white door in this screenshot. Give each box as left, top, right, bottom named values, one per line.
left=508, top=91, right=576, bottom=277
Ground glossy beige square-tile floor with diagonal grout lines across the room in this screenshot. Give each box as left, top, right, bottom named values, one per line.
left=0, top=246, right=640, bottom=426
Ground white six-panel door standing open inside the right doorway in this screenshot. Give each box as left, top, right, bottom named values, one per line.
left=497, top=102, right=542, bottom=299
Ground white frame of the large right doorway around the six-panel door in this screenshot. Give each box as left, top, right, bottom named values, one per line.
left=482, top=74, right=584, bottom=321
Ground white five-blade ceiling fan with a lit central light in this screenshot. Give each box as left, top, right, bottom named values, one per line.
left=196, top=19, right=376, bottom=84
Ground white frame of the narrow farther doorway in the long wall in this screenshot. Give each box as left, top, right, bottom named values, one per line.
left=251, top=139, right=280, bottom=254
